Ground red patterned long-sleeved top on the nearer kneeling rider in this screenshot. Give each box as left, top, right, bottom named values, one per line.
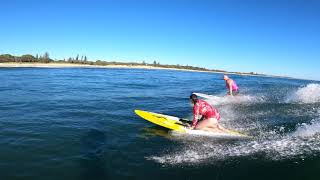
left=192, top=99, right=220, bottom=126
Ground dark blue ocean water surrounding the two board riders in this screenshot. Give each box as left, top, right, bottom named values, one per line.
left=0, top=68, right=320, bottom=180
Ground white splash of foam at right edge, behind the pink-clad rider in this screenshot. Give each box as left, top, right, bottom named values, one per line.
left=287, top=84, right=320, bottom=103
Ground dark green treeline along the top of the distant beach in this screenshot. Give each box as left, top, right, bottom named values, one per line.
left=0, top=52, right=261, bottom=75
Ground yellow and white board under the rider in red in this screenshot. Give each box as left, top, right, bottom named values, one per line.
left=135, top=110, right=250, bottom=138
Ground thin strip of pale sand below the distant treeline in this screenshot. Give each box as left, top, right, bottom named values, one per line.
left=0, top=62, right=290, bottom=78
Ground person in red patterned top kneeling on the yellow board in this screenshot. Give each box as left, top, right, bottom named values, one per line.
left=190, top=94, right=225, bottom=132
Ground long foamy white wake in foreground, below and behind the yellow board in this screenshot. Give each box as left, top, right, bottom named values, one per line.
left=147, top=119, right=320, bottom=165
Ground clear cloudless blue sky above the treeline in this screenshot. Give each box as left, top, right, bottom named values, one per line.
left=0, top=0, right=320, bottom=80
